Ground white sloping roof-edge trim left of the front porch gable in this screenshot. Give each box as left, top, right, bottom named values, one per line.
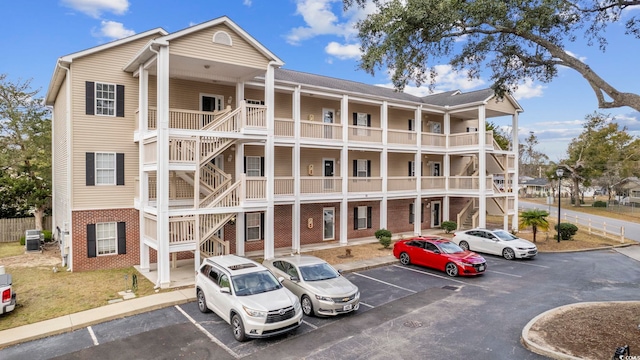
left=45, top=28, right=168, bottom=105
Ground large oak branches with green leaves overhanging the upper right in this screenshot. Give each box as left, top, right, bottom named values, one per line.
left=343, top=0, right=640, bottom=111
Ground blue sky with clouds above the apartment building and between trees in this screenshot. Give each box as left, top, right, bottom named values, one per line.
left=0, top=0, right=640, bottom=161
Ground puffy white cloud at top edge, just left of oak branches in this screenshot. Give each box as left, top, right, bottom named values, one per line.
left=286, top=0, right=356, bottom=45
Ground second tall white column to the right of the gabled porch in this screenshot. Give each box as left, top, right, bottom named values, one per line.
left=340, top=95, right=349, bottom=245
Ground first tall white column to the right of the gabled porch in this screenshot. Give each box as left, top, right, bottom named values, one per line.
left=291, top=86, right=301, bottom=252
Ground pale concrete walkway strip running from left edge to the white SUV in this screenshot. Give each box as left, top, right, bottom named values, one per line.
left=0, top=289, right=196, bottom=349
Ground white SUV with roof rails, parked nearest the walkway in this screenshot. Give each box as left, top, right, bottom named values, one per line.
left=196, top=255, right=302, bottom=341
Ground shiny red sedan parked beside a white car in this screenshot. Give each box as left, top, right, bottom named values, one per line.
left=393, top=236, right=487, bottom=276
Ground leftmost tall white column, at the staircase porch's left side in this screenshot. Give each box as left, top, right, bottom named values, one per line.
left=138, top=64, right=149, bottom=271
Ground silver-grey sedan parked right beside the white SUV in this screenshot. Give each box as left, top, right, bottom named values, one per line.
left=263, top=255, right=360, bottom=316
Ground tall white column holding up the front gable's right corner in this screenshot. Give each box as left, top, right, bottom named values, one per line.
left=264, top=64, right=275, bottom=259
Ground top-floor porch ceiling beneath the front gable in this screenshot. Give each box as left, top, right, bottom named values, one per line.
left=148, top=55, right=266, bottom=84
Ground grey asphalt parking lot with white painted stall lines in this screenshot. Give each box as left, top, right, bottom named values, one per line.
left=0, top=251, right=640, bottom=359
